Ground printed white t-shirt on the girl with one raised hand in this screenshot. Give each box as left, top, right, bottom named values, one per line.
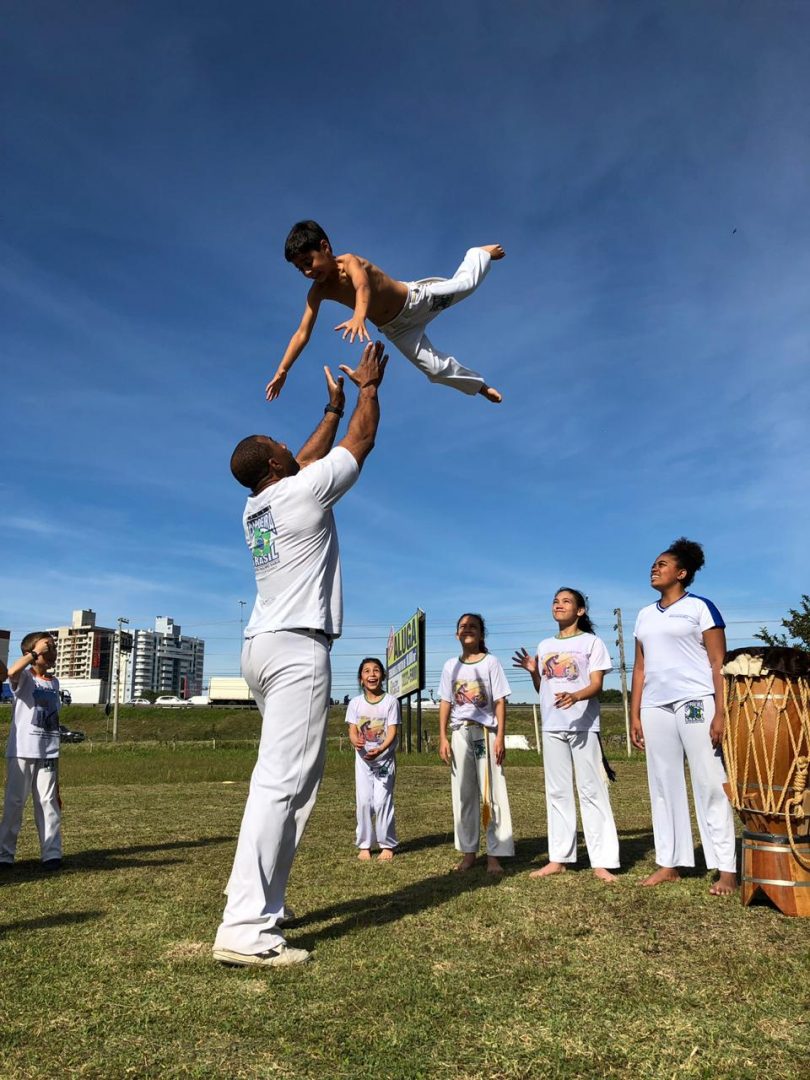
left=537, top=633, right=612, bottom=731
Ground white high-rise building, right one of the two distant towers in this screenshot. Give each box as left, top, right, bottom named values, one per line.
left=125, top=616, right=205, bottom=698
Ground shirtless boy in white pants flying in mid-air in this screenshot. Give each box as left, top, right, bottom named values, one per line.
left=267, top=221, right=505, bottom=403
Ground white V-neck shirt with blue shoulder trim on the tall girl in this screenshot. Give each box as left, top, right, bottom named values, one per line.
left=633, top=593, right=726, bottom=708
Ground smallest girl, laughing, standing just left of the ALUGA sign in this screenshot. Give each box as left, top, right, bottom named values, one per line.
left=346, top=657, right=400, bottom=862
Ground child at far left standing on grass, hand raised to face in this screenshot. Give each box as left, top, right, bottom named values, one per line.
left=0, top=631, right=62, bottom=870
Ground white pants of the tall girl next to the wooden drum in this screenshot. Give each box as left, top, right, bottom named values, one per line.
left=642, top=697, right=737, bottom=874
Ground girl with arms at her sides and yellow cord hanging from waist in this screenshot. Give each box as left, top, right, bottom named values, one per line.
left=438, top=612, right=515, bottom=874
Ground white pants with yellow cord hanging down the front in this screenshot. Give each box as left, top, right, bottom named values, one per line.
left=450, top=724, right=515, bottom=856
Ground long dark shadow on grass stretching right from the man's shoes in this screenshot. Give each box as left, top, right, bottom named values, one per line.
left=289, top=865, right=503, bottom=948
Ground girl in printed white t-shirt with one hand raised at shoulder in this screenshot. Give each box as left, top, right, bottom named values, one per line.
left=513, top=589, right=619, bottom=881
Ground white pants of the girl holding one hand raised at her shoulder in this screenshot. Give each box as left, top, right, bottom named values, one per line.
left=543, top=731, right=619, bottom=869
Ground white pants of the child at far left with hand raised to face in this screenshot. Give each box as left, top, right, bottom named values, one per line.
left=0, top=757, right=62, bottom=863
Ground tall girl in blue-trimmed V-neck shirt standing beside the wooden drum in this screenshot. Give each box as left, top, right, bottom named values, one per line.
left=630, top=537, right=737, bottom=896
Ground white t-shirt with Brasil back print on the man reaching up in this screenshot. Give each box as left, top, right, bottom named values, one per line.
left=242, top=446, right=360, bottom=637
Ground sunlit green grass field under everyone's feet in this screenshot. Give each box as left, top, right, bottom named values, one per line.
left=0, top=710, right=810, bottom=1080
